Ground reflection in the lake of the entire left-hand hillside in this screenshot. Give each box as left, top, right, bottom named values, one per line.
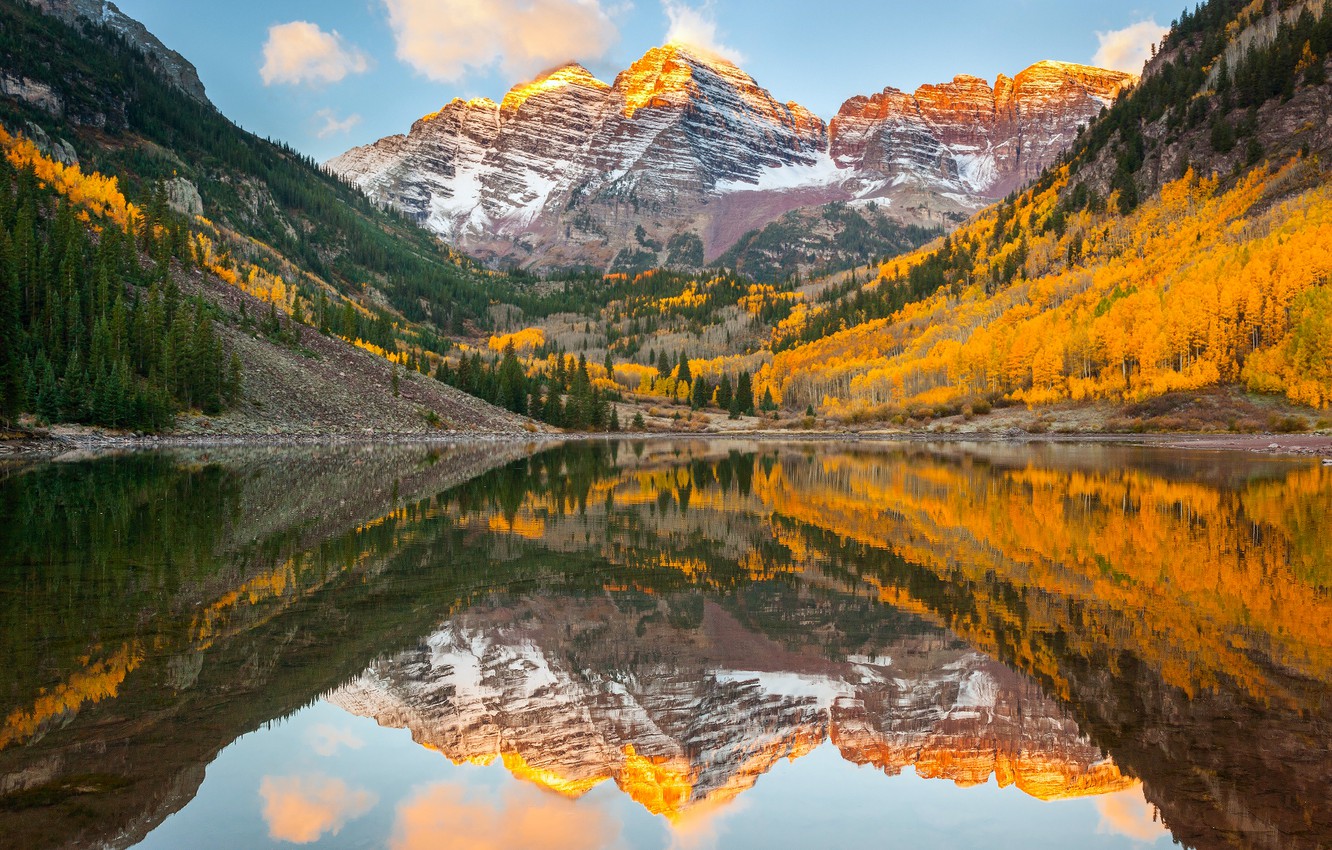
left=0, top=446, right=523, bottom=847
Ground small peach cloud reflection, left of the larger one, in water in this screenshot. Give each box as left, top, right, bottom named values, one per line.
left=258, top=775, right=378, bottom=845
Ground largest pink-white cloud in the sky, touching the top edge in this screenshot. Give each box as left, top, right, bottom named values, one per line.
left=384, top=0, right=619, bottom=83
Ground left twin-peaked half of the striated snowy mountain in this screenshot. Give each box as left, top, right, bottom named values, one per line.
left=329, top=45, right=827, bottom=266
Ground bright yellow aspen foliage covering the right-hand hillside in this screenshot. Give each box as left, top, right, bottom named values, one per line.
left=755, top=160, right=1332, bottom=408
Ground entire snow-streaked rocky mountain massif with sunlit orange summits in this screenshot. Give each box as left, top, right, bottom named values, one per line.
left=328, top=44, right=1132, bottom=270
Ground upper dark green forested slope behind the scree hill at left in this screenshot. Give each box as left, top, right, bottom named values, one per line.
left=0, top=1, right=503, bottom=330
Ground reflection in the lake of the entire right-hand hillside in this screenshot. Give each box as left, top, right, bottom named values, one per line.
left=450, top=444, right=1332, bottom=847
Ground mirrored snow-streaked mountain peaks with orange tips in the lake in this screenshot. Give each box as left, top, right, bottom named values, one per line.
left=329, top=600, right=1130, bottom=818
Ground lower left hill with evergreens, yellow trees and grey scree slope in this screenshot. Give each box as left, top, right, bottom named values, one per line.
left=0, top=129, right=533, bottom=437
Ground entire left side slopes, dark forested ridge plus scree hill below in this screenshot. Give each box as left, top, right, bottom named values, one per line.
left=0, top=3, right=546, bottom=436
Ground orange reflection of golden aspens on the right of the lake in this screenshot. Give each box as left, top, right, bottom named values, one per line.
left=479, top=442, right=1332, bottom=701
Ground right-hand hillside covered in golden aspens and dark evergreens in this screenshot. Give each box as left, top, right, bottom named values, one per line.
left=758, top=0, right=1332, bottom=428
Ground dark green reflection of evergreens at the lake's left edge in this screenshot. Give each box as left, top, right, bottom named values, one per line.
left=0, top=454, right=240, bottom=707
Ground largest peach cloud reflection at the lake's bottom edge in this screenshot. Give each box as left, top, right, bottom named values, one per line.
left=389, top=782, right=621, bottom=850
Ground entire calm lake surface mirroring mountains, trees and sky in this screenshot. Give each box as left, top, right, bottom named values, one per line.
left=0, top=441, right=1332, bottom=850
